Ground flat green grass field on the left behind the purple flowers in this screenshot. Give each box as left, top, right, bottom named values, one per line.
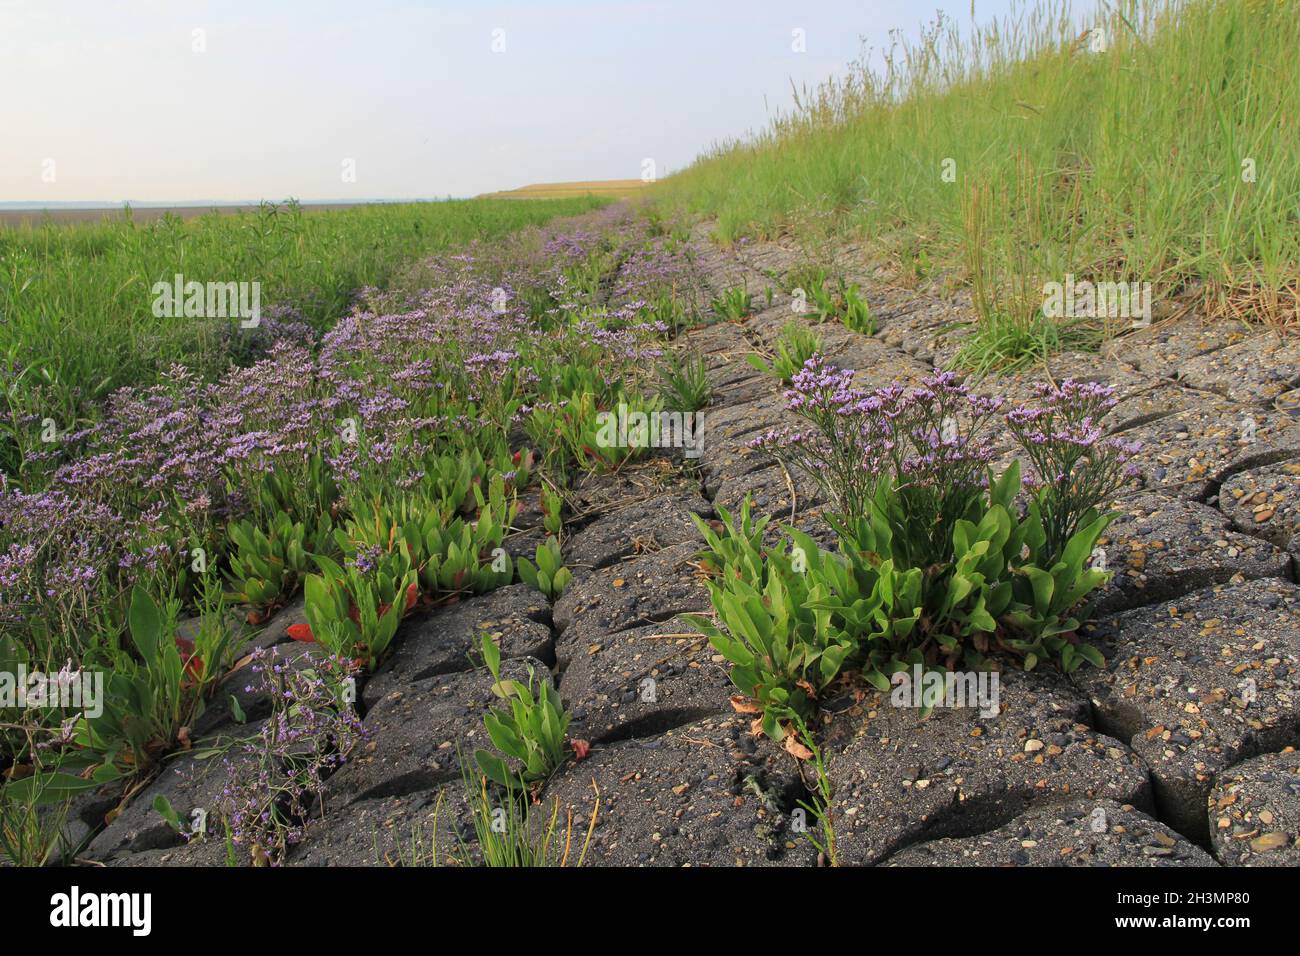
left=0, top=198, right=607, bottom=471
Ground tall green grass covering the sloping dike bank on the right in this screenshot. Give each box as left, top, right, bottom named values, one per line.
left=658, top=0, right=1300, bottom=361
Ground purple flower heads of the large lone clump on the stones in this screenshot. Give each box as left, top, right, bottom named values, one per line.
left=751, top=355, right=1138, bottom=564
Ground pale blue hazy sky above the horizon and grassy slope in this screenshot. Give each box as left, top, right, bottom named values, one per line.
left=0, top=0, right=1034, bottom=202
